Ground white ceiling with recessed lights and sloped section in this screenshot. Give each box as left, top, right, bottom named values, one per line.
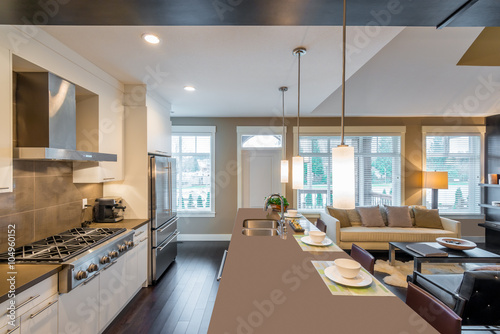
left=43, top=26, right=500, bottom=117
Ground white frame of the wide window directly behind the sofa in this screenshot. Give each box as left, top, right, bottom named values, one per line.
left=293, top=126, right=406, bottom=213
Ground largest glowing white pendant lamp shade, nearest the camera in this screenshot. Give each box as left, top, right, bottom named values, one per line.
left=332, top=145, right=356, bottom=209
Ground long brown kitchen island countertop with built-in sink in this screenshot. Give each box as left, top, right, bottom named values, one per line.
left=208, top=209, right=437, bottom=334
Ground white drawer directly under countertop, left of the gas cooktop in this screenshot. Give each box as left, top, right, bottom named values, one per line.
left=0, top=275, right=57, bottom=328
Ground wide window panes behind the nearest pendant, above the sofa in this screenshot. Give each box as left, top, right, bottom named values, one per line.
left=297, top=135, right=402, bottom=209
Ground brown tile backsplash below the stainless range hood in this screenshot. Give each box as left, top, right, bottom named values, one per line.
left=0, top=160, right=102, bottom=252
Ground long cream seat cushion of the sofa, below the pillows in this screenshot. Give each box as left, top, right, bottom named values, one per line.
left=340, top=226, right=456, bottom=242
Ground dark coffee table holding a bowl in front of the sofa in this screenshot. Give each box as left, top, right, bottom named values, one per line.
left=389, top=242, right=500, bottom=278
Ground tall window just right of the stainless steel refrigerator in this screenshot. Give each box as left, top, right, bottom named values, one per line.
left=172, top=126, right=215, bottom=217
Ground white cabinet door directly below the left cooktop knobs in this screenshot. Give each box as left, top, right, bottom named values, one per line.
left=57, top=276, right=100, bottom=334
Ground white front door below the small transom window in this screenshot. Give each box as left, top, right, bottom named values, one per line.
left=241, top=148, right=281, bottom=208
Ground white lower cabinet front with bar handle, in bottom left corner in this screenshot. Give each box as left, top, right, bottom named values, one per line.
left=21, top=294, right=59, bottom=334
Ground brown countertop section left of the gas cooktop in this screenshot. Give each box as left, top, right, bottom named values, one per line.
left=0, top=263, right=62, bottom=303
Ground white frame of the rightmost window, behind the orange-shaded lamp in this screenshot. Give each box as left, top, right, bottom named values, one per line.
left=422, top=125, right=486, bottom=219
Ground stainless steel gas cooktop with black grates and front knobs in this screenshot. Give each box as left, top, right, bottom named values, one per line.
left=0, top=227, right=134, bottom=293
